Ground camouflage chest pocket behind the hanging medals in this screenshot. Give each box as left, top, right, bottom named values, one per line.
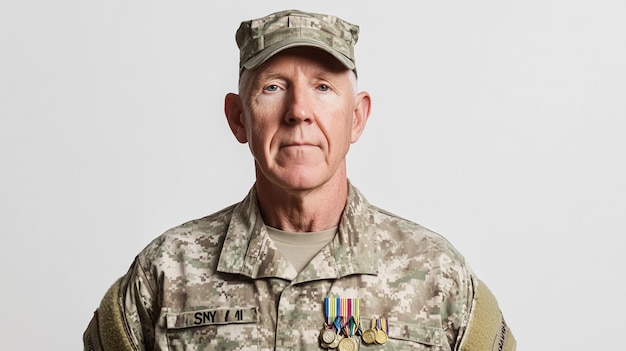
left=361, top=318, right=449, bottom=351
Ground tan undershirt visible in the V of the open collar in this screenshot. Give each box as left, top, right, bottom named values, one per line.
left=267, top=226, right=337, bottom=272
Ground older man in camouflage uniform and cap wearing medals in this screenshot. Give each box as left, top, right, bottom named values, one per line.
left=83, top=10, right=515, bottom=351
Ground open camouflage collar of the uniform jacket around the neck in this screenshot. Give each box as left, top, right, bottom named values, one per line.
left=217, top=183, right=380, bottom=283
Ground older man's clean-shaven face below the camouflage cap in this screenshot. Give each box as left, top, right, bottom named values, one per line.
left=231, top=48, right=369, bottom=194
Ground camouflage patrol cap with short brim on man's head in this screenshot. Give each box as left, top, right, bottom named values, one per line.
left=236, top=10, right=359, bottom=72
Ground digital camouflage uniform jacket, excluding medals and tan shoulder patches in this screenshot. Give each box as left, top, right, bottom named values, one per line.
left=121, top=185, right=475, bottom=350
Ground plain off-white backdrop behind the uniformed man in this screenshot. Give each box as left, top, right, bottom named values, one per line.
left=0, top=0, right=626, bottom=350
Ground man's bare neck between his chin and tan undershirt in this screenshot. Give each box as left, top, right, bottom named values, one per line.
left=256, top=170, right=348, bottom=232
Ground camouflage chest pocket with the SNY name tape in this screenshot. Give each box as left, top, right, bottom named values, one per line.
left=166, top=307, right=259, bottom=351
